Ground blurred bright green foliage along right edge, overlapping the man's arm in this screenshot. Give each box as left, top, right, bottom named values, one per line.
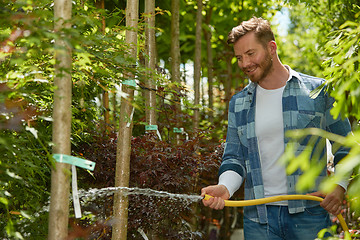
left=282, top=1, right=360, bottom=193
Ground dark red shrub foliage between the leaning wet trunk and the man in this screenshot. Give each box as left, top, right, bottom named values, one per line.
left=130, top=132, right=222, bottom=239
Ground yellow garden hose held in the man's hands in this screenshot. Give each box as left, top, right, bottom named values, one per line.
left=204, top=194, right=349, bottom=232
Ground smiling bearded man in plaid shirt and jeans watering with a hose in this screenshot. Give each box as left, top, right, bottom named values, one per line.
left=201, top=17, right=351, bottom=240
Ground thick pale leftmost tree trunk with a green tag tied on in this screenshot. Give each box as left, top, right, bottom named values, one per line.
left=48, top=0, right=72, bottom=240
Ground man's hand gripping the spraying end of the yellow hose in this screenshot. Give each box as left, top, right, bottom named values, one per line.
left=201, top=185, right=230, bottom=210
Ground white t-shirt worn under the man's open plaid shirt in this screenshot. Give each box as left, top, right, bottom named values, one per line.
left=255, top=85, right=287, bottom=205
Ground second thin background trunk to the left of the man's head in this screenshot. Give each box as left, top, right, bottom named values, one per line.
left=194, top=0, right=203, bottom=131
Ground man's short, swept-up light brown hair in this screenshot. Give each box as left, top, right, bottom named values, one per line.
left=227, top=17, right=275, bottom=46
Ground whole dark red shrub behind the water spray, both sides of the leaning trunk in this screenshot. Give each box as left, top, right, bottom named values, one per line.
left=73, top=130, right=222, bottom=239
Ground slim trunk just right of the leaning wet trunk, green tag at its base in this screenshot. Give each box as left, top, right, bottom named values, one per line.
left=145, top=0, right=157, bottom=125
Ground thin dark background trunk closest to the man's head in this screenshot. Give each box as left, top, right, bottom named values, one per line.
left=204, top=7, right=214, bottom=125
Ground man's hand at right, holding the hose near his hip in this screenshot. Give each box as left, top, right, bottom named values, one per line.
left=309, top=185, right=345, bottom=216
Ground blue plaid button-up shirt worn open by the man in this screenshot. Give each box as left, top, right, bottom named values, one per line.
left=219, top=68, right=351, bottom=223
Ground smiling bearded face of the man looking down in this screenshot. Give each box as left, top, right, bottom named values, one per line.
left=234, top=32, right=273, bottom=83
